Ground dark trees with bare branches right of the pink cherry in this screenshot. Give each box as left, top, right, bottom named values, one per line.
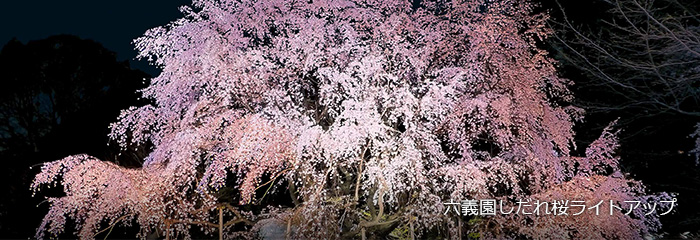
left=546, top=0, right=700, bottom=235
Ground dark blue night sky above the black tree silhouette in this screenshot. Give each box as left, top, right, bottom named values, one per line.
left=0, top=0, right=191, bottom=75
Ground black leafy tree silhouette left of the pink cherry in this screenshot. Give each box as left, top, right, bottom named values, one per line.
left=0, top=35, right=149, bottom=238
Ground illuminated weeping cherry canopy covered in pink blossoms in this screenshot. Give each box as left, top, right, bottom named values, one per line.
left=32, top=0, right=666, bottom=239
